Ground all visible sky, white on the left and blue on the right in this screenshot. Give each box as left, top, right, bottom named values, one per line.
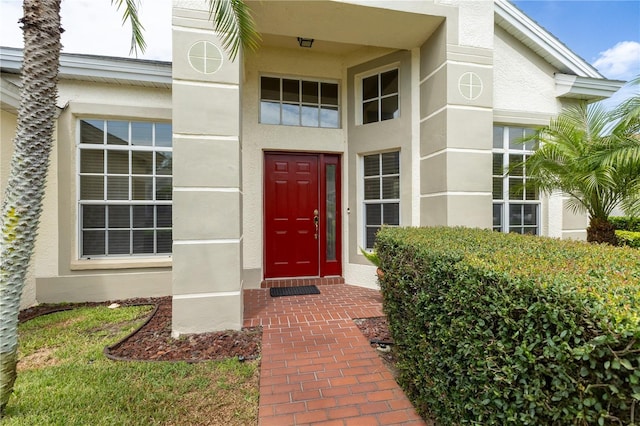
left=0, top=0, right=640, bottom=96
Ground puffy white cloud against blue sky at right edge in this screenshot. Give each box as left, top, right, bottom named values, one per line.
left=593, top=41, right=640, bottom=80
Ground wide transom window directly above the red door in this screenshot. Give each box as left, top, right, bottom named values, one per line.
left=260, top=76, right=340, bottom=129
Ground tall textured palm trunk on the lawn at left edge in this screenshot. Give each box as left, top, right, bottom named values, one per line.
left=0, top=0, right=62, bottom=417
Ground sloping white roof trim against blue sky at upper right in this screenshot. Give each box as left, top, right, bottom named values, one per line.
left=494, top=0, right=605, bottom=79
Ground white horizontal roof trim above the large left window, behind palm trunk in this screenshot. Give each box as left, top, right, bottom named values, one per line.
left=0, top=47, right=172, bottom=86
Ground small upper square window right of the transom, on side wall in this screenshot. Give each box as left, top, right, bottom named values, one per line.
left=361, top=68, right=400, bottom=124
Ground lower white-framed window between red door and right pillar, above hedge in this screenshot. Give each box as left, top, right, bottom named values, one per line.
left=363, top=151, right=400, bottom=249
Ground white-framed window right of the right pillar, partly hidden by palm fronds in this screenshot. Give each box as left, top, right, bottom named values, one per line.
left=493, top=126, right=540, bottom=235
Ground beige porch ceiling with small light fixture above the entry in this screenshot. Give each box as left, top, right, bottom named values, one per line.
left=248, top=0, right=443, bottom=54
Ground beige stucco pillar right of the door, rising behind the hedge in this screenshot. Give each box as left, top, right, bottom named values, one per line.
left=419, top=2, right=493, bottom=228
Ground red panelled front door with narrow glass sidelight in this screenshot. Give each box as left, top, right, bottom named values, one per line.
left=264, top=153, right=342, bottom=278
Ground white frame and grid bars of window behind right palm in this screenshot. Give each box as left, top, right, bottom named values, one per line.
left=492, top=124, right=542, bottom=235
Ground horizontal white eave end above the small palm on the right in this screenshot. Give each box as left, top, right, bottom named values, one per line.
left=555, top=74, right=625, bottom=102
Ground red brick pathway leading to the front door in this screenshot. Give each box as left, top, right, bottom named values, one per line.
left=244, top=284, right=425, bottom=426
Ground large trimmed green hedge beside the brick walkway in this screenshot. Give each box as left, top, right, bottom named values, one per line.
left=376, top=228, right=640, bottom=425
